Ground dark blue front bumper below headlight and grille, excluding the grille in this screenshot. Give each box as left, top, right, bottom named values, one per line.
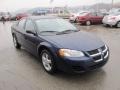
left=58, top=57, right=109, bottom=73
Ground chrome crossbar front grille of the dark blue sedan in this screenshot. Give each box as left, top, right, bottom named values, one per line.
left=87, top=45, right=108, bottom=62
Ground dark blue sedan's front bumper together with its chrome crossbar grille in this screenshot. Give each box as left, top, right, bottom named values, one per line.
left=57, top=45, right=109, bottom=73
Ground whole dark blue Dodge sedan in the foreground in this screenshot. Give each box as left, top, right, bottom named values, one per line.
left=11, top=16, right=109, bottom=73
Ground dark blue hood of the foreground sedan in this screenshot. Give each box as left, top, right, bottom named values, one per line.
left=41, top=31, right=104, bottom=51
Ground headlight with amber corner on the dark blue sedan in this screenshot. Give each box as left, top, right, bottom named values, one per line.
left=59, top=49, right=84, bottom=57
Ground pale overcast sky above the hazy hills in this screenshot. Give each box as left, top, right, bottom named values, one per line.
left=0, top=0, right=120, bottom=11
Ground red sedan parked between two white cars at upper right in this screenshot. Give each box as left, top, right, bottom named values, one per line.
left=77, top=12, right=103, bottom=25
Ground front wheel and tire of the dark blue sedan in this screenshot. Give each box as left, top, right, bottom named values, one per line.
left=40, top=49, right=56, bottom=74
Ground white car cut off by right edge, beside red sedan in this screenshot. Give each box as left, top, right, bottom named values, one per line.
left=102, top=13, right=120, bottom=28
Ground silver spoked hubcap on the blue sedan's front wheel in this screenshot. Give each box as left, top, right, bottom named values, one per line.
left=42, top=53, right=52, bottom=71
